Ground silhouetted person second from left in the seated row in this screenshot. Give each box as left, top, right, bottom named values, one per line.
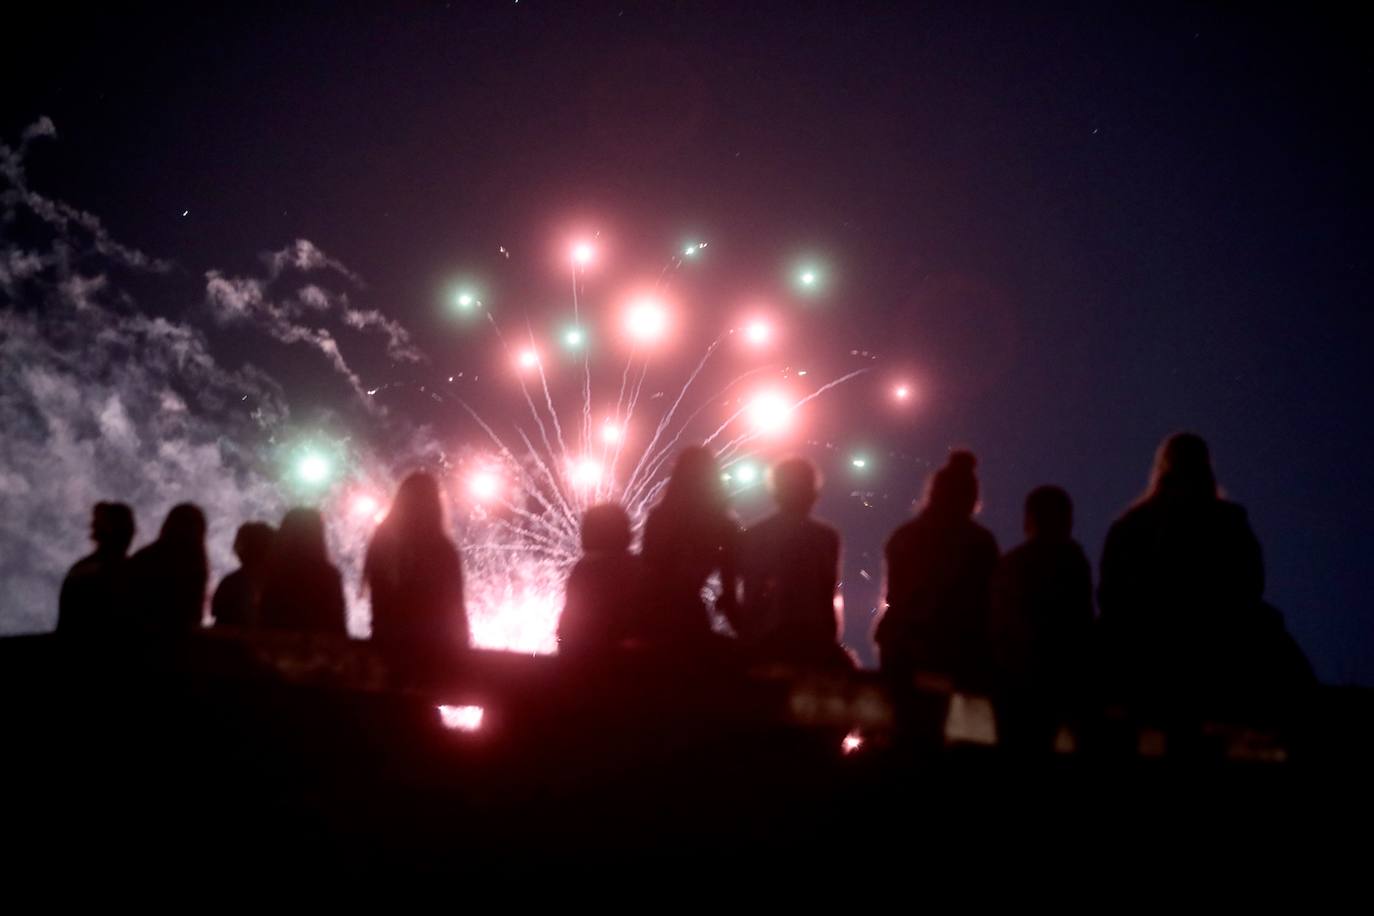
left=126, top=503, right=210, bottom=636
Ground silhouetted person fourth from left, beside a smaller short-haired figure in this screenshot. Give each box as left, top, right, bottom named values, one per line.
left=260, top=507, right=348, bottom=636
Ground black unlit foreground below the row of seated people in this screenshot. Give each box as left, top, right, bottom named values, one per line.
left=0, top=636, right=1374, bottom=893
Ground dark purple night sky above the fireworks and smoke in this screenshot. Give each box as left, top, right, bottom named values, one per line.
left=0, top=0, right=1374, bottom=684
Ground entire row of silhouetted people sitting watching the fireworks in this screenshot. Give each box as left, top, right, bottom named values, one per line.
left=58, top=433, right=1311, bottom=735
